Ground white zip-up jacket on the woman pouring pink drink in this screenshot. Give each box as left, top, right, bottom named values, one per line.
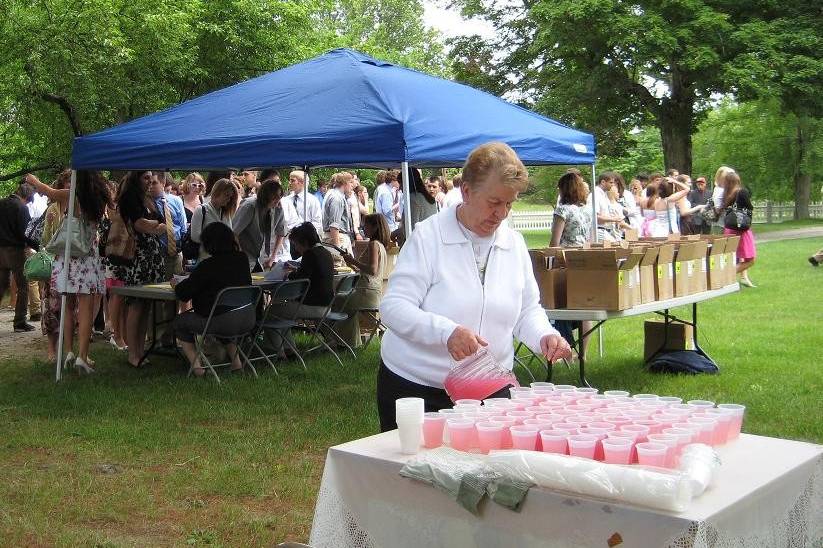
left=380, top=203, right=557, bottom=388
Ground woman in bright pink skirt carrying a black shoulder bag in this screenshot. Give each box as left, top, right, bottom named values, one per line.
left=718, top=170, right=757, bottom=287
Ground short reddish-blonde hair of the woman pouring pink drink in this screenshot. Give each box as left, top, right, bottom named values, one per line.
left=463, top=142, right=529, bottom=192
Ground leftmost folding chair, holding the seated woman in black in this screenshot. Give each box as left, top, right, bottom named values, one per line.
left=188, top=285, right=261, bottom=383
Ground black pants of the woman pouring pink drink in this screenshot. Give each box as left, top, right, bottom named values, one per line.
left=377, top=360, right=509, bottom=432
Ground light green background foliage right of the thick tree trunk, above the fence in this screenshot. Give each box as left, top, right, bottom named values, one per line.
left=693, top=101, right=823, bottom=201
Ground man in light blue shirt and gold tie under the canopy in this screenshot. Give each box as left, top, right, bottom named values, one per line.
left=149, top=171, right=186, bottom=346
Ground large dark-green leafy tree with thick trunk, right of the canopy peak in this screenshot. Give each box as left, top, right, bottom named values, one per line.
left=448, top=0, right=820, bottom=176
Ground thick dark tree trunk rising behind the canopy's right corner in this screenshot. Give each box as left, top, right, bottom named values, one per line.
left=656, top=69, right=694, bottom=173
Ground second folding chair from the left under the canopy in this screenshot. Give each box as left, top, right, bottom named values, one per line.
left=248, top=280, right=311, bottom=375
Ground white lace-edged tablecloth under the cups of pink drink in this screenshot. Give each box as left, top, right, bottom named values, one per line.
left=310, top=431, right=823, bottom=548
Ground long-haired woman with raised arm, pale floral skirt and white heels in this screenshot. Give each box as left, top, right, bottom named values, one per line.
left=26, top=171, right=111, bottom=373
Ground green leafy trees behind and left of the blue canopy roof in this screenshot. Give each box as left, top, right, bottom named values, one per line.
left=0, top=0, right=445, bottom=179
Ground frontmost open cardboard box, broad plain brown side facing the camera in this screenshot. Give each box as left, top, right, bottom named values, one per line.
left=565, top=247, right=642, bottom=310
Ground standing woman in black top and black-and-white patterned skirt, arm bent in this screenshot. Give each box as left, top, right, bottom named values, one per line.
left=117, top=171, right=166, bottom=367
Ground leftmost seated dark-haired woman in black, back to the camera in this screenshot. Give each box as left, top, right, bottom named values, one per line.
left=171, top=223, right=255, bottom=377
